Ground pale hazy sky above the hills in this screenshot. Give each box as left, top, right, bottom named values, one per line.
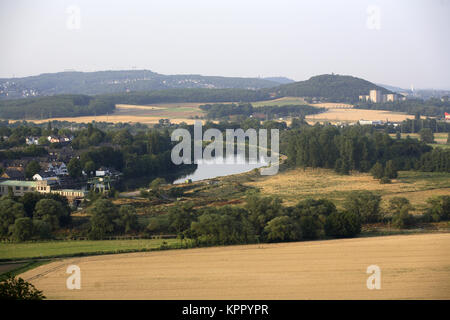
left=0, top=0, right=450, bottom=89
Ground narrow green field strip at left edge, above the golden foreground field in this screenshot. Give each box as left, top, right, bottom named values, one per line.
left=0, top=239, right=180, bottom=260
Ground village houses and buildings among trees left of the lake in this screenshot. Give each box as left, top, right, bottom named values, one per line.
left=0, top=135, right=121, bottom=206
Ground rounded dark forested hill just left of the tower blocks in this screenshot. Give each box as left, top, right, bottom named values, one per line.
left=265, top=74, right=391, bottom=103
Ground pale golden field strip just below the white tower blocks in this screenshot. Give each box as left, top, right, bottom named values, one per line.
left=306, top=104, right=414, bottom=123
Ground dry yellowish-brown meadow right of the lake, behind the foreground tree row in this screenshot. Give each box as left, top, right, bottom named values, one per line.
left=245, top=168, right=450, bottom=209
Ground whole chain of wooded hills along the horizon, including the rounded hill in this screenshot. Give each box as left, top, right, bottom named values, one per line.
left=0, top=70, right=402, bottom=119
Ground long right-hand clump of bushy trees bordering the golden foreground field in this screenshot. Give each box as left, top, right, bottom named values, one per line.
left=146, top=191, right=450, bottom=245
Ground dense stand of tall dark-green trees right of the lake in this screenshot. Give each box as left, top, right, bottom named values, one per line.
left=280, top=125, right=450, bottom=178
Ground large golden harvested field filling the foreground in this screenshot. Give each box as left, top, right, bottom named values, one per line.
left=21, top=233, right=450, bottom=299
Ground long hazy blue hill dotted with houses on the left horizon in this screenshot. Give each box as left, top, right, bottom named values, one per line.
left=0, top=70, right=280, bottom=99
